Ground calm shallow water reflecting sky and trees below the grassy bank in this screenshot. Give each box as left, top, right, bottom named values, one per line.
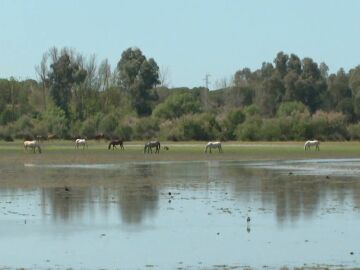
left=0, top=159, right=360, bottom=269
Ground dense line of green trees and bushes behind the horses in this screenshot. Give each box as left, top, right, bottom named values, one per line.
left=0, top=47, right=360, bottom=141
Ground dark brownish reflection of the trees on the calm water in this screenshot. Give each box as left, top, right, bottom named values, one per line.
left=4, top=161, right=360, bottom=224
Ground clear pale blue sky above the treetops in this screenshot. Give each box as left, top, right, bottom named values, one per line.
left=0, top=0, right=360, bottom=88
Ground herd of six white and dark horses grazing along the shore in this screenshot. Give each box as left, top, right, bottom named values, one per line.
left=24, top=138, right=320, bottom=154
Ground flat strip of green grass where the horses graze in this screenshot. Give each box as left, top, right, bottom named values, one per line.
left=0, top=140, right=360, bottom=162
